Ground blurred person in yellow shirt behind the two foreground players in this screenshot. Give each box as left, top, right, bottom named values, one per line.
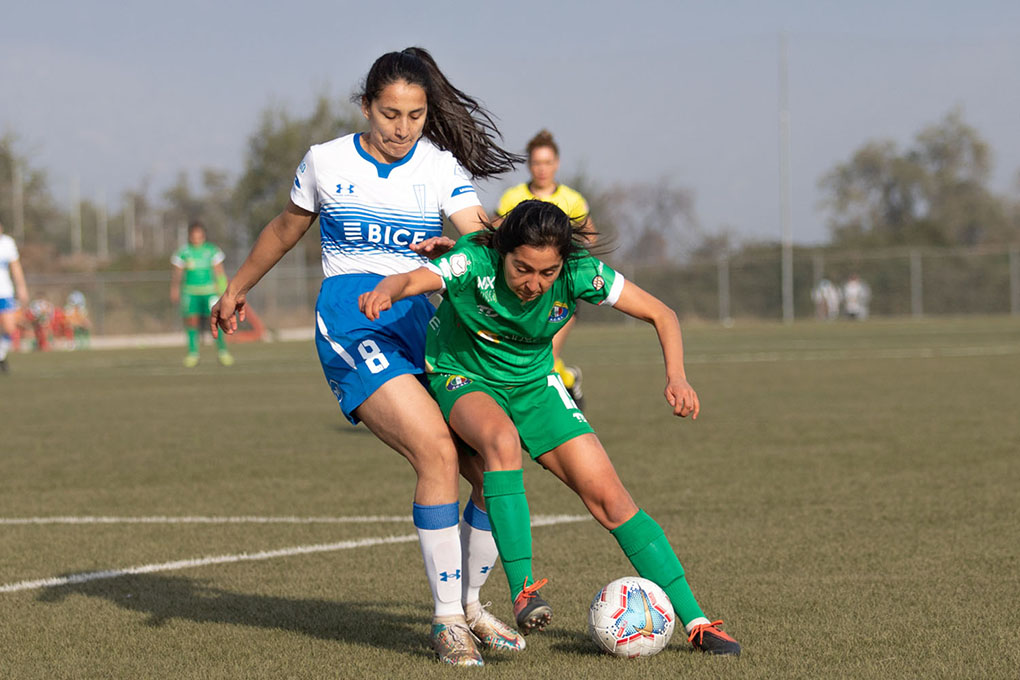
left=496, top=129, right=595, bottom=409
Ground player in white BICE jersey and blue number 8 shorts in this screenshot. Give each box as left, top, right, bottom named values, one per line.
left=211, top=48, right=524, bottom=666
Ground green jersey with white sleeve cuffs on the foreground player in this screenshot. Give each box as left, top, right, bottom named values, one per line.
left=425, top=234, right=623, bottom=384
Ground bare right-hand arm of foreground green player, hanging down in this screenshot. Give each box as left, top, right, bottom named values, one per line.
left=614, top=281, right=701, bottom=418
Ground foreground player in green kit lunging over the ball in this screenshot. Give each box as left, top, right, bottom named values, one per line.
left=358, top=200, right=741, bottom=656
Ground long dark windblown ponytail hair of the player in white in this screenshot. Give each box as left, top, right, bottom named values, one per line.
left=353, top=47, right=524, bottom=177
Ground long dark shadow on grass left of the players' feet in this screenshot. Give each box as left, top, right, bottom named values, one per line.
left=38, top=574, right=432, bottom=658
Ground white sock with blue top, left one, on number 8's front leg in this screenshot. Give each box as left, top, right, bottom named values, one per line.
left=413, top=503, right=464, bottom=617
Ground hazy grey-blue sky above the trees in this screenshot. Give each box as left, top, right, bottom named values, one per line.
left=0, top=0, right=1020, bottom=243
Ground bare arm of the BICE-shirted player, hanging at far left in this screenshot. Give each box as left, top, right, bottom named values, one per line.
left=209, top=202, right=316, bottom=337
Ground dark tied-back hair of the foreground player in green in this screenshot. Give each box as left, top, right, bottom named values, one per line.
left=471, top=199, right=594, bottom=262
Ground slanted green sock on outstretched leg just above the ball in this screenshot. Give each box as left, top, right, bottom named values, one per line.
left=610, top=510, right=705, bottom=625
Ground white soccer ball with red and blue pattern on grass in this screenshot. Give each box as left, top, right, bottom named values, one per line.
left=588, top=576, right=676, bottom=659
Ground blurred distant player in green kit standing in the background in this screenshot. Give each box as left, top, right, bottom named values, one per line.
left=170, top=221, right=234, bottom=368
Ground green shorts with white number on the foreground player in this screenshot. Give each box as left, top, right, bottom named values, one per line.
left=427, top=372, right=595, bottom=459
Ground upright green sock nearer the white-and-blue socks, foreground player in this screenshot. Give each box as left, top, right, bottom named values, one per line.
left=481, top=470, right=534, bottom=599
